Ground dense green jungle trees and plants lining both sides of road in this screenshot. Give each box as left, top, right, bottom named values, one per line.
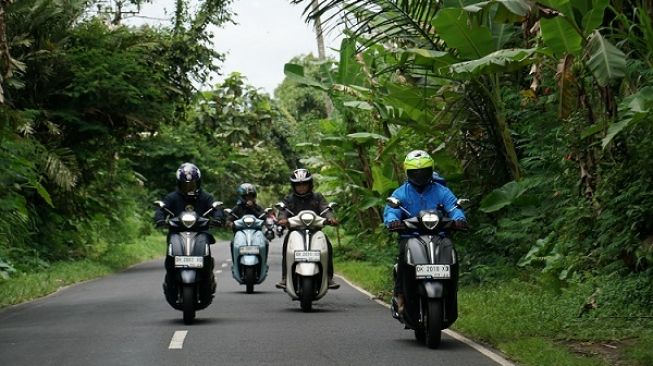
left=0, top=0, right=653, bottom=365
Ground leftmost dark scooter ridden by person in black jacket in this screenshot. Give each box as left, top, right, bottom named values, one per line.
left=155, top=201, right=222, bottom=324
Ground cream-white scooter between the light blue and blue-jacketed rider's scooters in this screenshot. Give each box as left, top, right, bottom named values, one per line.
left=276, top=202, right=336, bottom=312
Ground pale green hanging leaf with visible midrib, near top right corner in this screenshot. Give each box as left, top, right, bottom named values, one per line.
left=586, top=31, right=626, bottom=86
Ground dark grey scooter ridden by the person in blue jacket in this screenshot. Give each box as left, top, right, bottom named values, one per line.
left=386, top=197, right=463, bottom=348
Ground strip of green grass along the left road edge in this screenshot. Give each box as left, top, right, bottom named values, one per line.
left=0, top=233, right=165, bottom=308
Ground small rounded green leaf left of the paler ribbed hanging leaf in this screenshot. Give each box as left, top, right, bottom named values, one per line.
left=540, top=16, right=583, bottom=56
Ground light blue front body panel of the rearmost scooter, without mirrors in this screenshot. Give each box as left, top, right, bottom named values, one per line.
left=231, top=215, right=270, bottom=285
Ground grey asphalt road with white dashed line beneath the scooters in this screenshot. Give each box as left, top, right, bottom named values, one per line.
left=0, top=239, right=506, bottom=366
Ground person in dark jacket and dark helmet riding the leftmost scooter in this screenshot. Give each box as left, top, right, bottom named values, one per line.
left=154, top=163, right=224, bottom=294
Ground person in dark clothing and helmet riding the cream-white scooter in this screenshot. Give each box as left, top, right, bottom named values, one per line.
left=276, top=169, right=340, bottom=289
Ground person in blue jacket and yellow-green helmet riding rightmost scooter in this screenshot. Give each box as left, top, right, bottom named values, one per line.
left=383, top=150, right=467, bottom=313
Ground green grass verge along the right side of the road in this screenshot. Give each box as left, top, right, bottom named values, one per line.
left=335, top=261, right=653, bottom=366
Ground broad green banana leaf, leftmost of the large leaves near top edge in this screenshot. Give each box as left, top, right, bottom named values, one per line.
left=432, top=8, right=494, bottom=60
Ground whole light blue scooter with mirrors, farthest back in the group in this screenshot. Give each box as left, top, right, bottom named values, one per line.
left=224, top=208, right=274, bottom=294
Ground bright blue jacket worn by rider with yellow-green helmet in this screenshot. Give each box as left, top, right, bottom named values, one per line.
left=383, top=181, right=466, bottom=226
